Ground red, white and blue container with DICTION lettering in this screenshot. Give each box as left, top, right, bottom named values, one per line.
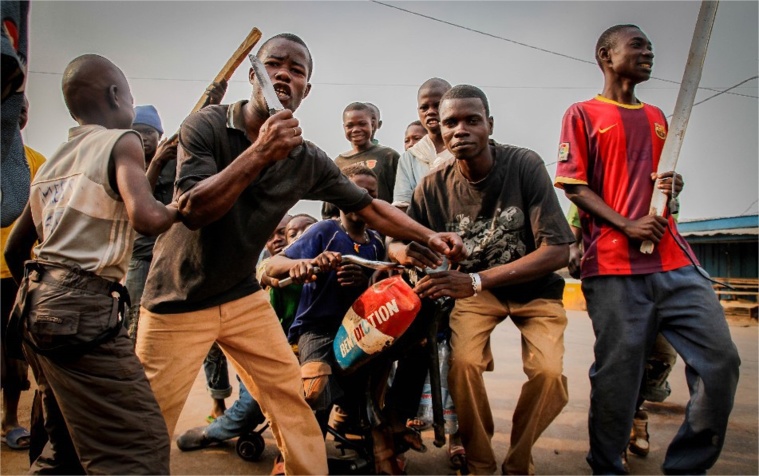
left=333, top=276, right=422, bottom=370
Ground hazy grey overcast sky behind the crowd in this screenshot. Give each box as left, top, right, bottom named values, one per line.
left=24, top=0, right=759, bottom=219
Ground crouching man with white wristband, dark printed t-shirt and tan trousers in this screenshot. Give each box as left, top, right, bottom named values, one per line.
left=388, top=85, right=574, bottom=474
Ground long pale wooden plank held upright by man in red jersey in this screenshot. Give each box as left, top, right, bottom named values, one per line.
left=640, top=0, right=719, bottom=254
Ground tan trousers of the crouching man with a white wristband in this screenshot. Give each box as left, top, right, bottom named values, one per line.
left=448, top=291, right=569, bottom=474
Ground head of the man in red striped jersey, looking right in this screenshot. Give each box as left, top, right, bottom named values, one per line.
left=606, top=28, right=654, bottom=84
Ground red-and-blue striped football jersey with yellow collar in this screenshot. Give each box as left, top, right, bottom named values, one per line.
left=554, top=96, right=695, bottom=278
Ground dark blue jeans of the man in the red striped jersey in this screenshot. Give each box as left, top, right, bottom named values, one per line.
left=582, top=266, right=740, bottom=474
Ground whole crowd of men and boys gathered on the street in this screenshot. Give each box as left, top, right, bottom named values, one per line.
left=3, top=2, right=740, bottom=474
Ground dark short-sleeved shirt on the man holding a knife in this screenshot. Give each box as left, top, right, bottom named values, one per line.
left=142, top=101, right=372, bottom=313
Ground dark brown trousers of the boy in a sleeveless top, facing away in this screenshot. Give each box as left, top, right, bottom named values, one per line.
left=17, top=262, right=170, bottom=474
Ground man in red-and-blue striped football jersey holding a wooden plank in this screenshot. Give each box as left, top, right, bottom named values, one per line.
left=556, top=25, right=740, bottom=474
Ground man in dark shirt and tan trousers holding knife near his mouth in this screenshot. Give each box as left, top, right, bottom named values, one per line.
left=137, top=34, right=470, bottom=474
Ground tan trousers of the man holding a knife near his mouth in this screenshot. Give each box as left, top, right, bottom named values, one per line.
left=136, top=291, right=328, bottom=474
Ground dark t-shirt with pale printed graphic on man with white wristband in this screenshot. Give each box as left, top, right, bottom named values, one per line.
left=408, top=141, right=574, bottom=302
